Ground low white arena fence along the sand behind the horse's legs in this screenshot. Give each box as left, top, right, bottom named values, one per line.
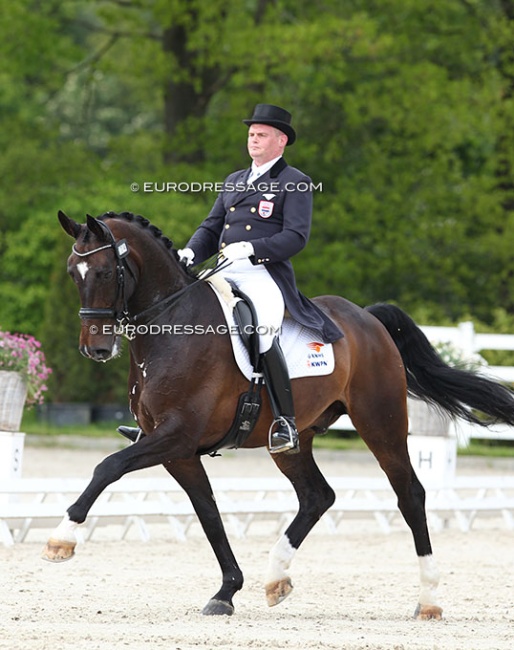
left=0, top=468, right=514, bottom=546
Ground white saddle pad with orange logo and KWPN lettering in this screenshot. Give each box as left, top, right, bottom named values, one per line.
left=208, top=282, right=335, bottom=380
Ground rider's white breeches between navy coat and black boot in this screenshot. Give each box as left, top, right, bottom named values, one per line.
left=223, top=260, right=285, bottom=353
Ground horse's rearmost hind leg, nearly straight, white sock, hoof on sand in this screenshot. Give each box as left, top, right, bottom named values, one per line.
left=363, top=415, right=442, bottom=619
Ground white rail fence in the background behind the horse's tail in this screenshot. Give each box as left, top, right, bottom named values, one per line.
left=332, top=321, right=514, bottom=447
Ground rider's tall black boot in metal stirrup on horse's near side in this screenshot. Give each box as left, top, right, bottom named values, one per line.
left=261, top=340, right=300, bottom=454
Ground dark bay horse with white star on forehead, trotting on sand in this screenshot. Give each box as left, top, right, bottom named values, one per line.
left=43, top=212, right=514, bottom=619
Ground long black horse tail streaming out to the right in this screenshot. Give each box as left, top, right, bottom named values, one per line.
left=366, top=304, right=514, bottom=426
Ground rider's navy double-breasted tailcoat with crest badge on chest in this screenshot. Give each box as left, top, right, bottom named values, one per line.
left=187, top=158, right=343, bottom=343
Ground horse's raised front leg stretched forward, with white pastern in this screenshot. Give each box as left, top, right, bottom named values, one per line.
left=42, top=429, right=190, bottom=562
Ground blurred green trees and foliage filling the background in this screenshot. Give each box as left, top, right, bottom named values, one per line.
left=0, top=0, right=514, bottom=401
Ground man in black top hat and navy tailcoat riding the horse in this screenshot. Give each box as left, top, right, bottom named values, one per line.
left=178, top=104, right=342, bottom=454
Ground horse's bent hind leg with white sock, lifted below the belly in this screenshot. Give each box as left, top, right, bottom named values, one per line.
left=266, top=439, right=335, bottom=607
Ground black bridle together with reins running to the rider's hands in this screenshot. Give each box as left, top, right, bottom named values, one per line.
left=72, top=221, right=231, bottom=338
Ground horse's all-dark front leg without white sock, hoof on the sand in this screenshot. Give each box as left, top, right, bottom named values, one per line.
left=164, top=456, right=243, bottom=616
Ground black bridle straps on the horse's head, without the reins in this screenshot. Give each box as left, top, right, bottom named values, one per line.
left=72, top=221, right=136, bottom=325
